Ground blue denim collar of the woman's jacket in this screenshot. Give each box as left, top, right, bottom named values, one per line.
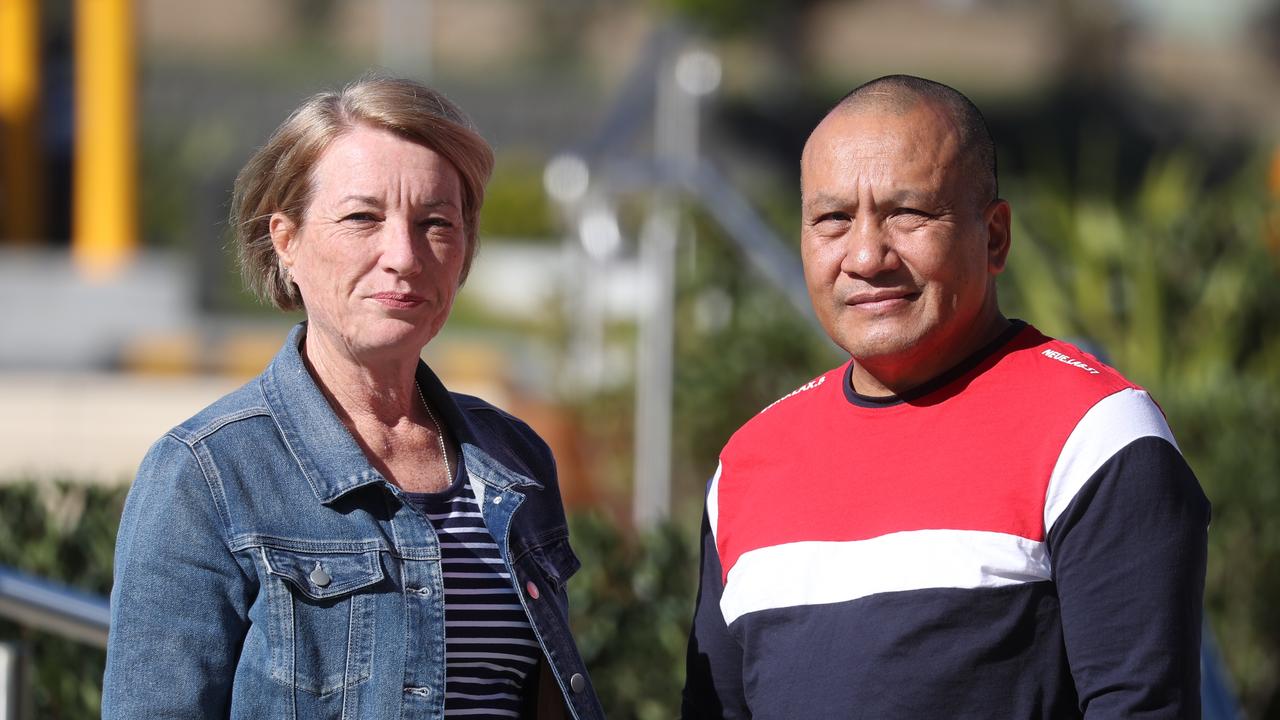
left=261, top=322, right=540, bottom=505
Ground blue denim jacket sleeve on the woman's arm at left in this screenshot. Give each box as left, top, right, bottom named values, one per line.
left=102, top=436, right=248, bottom=720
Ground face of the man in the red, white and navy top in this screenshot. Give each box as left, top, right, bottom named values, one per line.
left=800, top=102, right=1009, bottom=380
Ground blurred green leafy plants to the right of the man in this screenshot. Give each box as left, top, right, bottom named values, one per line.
left=1002, top=156, right=1280, bottom=717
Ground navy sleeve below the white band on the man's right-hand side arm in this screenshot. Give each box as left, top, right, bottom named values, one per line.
left=1048, top=437, right=1210, bottom=719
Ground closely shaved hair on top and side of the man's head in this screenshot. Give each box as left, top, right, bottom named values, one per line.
left=827, top=74, right=1000, bottom=205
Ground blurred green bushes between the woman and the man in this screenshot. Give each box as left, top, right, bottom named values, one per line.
left=555, top=199, right=841, bottom=720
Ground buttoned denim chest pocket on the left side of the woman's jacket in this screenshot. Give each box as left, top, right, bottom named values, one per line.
left=262, top=547, right=384, bottom=696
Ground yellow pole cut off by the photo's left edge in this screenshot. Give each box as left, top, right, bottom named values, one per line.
left=0, top=0, right=45, bottom=243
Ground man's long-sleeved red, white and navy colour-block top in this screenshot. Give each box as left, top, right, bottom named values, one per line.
left=684, top=322, right=1210, bottom=720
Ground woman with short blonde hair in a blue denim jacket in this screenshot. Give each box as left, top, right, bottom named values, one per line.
left=102, top=78, right=603, bottom=719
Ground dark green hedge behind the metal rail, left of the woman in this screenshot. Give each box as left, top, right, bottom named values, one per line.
left=0, top=483, right=124, bottom=720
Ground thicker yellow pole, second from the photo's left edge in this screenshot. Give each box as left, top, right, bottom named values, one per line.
left=72, top=0, right=138, bottom=279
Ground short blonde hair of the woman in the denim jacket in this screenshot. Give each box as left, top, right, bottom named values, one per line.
left=230, top=76, right=493, bottom=310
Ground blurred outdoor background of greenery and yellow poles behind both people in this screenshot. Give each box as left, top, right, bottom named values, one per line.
left=0, top=0, right=1280, bottom=719
